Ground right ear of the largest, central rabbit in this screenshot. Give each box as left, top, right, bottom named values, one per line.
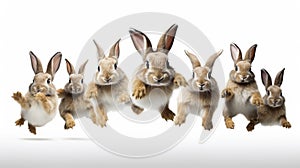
left=157, top=24, right=178, bottom=54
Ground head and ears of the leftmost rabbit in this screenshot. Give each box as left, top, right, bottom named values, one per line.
left=29, top=51, right=62, bottom=96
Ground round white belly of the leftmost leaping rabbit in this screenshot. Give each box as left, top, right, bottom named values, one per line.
left=21, top=96, right=56, bottom=127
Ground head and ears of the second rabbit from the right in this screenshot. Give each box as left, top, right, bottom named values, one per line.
left=230, top=43, right=257, bottom=84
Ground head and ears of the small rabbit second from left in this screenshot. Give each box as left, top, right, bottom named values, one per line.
left=65, top=59, right=88, bottom=95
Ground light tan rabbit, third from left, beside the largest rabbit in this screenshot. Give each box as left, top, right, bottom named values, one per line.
left=86, top=39, right=143, bottom=127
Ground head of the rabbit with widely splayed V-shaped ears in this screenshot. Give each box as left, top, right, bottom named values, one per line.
left=185, top=50, right=223, bottom=92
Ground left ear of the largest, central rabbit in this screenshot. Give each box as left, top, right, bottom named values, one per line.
left=129, top=28, right=153, bottom=60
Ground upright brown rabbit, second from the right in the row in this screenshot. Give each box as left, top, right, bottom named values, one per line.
left=221, top=43, right=263, bottom=131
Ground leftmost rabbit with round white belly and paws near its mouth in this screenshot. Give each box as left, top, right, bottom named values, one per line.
left=12, top=51, right=62, bottom=134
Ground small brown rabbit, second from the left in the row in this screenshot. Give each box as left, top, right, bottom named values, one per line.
left=57, top=59, right=96, bottom=129
